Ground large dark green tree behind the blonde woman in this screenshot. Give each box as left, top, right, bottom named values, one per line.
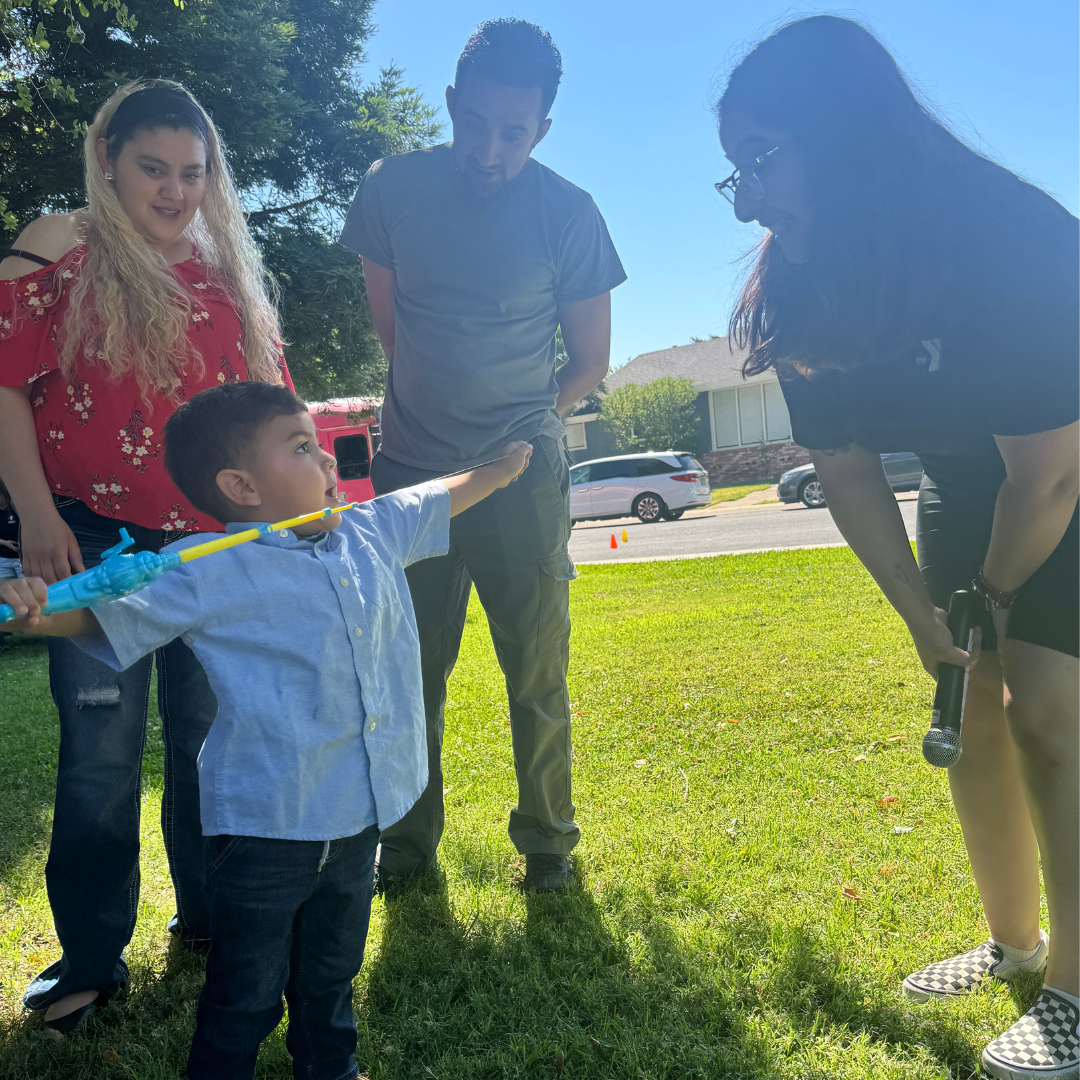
left=0, top=0, right=440, bottom=399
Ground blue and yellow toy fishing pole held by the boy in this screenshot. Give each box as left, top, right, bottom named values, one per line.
left=0, top=458, right=511, bottom=622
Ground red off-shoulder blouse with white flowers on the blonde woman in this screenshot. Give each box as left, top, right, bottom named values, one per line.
left=0, top=246, right=293, bottom=531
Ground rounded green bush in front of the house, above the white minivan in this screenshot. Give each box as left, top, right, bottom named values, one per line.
left=599, top=378, right=700, bottom=454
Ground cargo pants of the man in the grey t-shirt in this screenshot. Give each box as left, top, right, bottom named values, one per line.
left=372, top=435, right=580, bottom=877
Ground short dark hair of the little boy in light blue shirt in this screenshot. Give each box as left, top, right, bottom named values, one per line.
left=165, top=382, right=308, bottom=523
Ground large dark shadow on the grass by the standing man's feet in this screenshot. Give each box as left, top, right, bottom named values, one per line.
left=359, top=874, right=993, bottom=1080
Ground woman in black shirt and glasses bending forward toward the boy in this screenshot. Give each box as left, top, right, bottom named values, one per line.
left=716, top=16, right=1080, bottom=1080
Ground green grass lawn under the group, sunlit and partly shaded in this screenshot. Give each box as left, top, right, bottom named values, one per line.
left=0, top=549, right=1038, bottom=1080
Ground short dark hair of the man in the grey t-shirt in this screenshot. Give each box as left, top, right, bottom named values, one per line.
left=454, top=18, right=563, bottom=120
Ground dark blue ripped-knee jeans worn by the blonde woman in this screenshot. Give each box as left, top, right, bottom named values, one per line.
left=23, top=500, right=217, bottom=1009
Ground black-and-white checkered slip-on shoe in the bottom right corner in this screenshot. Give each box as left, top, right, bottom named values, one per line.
left=983, top=989, right=1080, bottom=1080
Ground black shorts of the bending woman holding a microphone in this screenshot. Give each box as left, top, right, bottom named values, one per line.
left=915, top=476, right=1080, bottom=657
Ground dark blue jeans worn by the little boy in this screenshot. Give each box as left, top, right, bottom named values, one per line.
left=188, top=825, right=379, bottom=1080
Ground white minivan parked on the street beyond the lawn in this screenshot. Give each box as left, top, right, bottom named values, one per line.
left=570, top=450, right=712, bottom=523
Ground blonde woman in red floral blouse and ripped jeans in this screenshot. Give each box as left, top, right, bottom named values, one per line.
left=0, top=81, right=288, bottom=1034
